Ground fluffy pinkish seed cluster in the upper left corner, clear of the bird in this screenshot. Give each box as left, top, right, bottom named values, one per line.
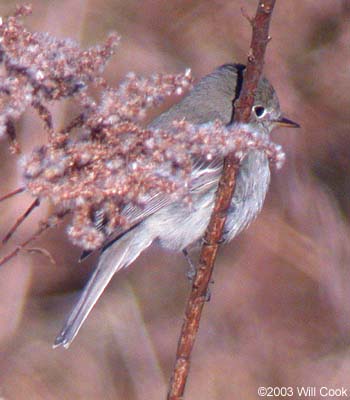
left=0, top=6, right=118, bottom=151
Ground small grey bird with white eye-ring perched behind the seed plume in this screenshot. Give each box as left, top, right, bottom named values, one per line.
left=54, top=64, right=299, bottom=348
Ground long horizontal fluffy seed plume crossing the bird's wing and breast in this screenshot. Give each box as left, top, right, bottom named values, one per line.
left=25, top=115, right=284, bottom=250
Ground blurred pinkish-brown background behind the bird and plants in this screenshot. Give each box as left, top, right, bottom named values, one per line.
left=0, top=0, right=350, bottom=400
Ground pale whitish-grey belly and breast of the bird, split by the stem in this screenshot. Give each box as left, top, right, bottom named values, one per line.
left=145, top=151, right=270, bottom=251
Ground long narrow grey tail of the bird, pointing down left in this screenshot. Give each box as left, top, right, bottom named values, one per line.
left=53, top=224, right=153, bottom=348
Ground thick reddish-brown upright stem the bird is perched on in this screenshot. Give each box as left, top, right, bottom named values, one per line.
left=168, top=0, right=275, bottom=400
